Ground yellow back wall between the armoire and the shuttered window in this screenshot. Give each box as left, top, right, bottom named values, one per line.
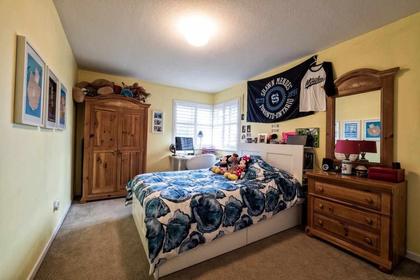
left=78, top=70, right=213, bottom=172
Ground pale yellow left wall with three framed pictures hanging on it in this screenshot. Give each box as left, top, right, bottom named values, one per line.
left=0, top=0, right=77, bottom=279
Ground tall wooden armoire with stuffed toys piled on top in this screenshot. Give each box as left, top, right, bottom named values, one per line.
left=75, top=94, right=150, bottom=202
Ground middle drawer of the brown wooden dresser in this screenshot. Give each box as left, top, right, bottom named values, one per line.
left=313, top=198, right=380, bottom=230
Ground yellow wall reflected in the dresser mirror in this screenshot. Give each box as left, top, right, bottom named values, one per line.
left=335, top=90, right=381, bottom=162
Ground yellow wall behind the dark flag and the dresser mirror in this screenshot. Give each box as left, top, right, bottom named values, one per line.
left=215, top=13, right=420, bottom=254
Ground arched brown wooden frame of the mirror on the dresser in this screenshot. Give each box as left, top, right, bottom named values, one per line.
left=325, top=67, right=400, bottom=166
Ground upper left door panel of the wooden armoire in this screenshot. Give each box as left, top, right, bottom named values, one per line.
left=90, top=107, right=118, bottom=150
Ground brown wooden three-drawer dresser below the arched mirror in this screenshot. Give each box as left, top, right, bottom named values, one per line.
left=306, top=171, right=407, bottom=272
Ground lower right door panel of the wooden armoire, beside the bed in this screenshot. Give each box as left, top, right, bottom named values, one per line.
left=119, top=151, right=143, bottom=190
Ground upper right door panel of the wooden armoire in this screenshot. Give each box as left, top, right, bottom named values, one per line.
left=118, top=112, right=142, bottom=149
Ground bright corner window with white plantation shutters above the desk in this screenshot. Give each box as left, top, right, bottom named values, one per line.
left=174, top=100, right=239, bottom=150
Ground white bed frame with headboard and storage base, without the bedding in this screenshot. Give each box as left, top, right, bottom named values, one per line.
left=132, top=144, right=303, bottom=279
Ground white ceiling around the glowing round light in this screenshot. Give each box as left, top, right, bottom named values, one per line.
left=54, top=0, right=420, bottom=92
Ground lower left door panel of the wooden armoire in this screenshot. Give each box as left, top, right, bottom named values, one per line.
left=90, top=152, right=118, bottom=194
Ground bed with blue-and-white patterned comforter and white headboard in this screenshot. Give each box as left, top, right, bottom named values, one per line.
left=130, top=144, right=303, bottom=279
